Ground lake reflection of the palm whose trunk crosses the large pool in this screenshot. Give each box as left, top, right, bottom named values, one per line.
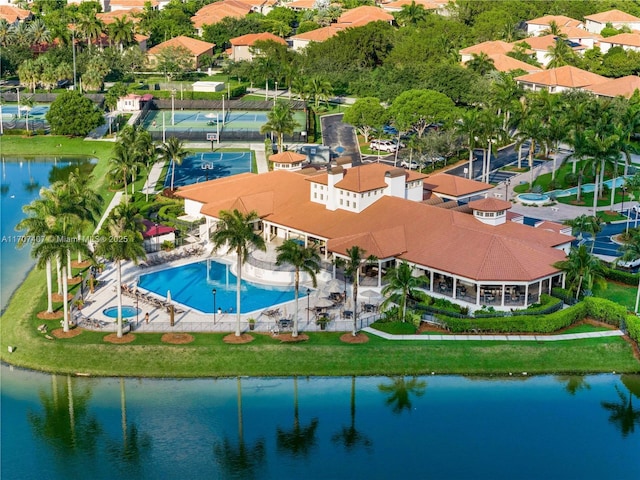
left=213, top=377, right=266, bottom=479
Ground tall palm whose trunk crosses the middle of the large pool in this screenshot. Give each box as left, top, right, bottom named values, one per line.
left=211, top=209, right=266, bottom=337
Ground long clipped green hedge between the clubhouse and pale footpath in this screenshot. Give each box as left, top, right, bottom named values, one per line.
left=438, top=297, right=627, bottom=333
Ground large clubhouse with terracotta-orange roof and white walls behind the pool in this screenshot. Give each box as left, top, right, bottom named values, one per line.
left=177, top=160, right=573, bottom=310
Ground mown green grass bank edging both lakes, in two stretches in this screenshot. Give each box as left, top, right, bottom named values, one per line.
left=0, top=137, right=640, bottom=377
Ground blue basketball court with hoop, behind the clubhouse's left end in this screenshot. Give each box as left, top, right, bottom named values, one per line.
left=164, top=152, right=251, bottom=188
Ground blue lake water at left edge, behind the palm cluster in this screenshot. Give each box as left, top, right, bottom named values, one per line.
left=0, top=157, right=93, bottom=310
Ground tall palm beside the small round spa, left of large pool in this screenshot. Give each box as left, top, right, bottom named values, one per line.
left=96, top=201, right=145, bottom=338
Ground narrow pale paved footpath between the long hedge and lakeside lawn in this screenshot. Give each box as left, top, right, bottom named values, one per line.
left=362, top=327, right=624, bottom=342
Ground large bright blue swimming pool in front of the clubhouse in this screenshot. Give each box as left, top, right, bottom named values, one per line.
left=138, top=260, right=304, bottom=313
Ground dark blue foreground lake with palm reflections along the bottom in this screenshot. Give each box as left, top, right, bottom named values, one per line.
left=1, top=366, right=640, bottom=479
